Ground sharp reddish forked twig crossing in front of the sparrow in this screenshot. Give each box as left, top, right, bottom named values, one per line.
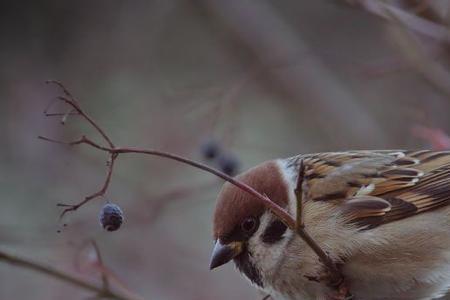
left=38, top=80, right=345, bottom=299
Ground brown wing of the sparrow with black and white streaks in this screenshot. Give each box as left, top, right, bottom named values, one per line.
left=294, top=150, right=450, bottom=229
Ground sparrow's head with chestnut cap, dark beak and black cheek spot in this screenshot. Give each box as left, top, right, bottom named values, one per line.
left=210, top=161, right=289, bottom=287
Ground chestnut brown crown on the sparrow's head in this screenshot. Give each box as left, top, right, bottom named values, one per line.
left=213, top=161, right=288, bottom=242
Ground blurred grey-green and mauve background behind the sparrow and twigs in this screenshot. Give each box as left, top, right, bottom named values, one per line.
left=0, top=0, right=450, bottom=300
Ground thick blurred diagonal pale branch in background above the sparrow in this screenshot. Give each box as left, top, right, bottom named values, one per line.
left=202, top=0, right=385, bottom=147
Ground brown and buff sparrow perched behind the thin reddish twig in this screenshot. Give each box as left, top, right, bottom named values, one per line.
left=210, top=150, right=450, bottom=300
